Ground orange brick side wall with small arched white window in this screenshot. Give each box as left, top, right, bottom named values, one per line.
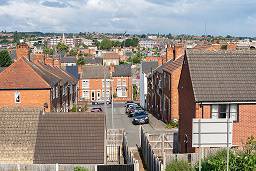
left=0, top=90, right=51, bottom=112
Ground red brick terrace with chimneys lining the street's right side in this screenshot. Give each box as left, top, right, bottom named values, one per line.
left=147, top=44, right=184, bottom=122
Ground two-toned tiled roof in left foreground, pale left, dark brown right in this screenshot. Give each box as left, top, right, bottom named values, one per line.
left=0, top=108, right=105, bottom=164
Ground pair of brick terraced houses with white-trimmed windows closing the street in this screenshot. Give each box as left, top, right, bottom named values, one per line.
left=79, top=65, right=132, bottom=102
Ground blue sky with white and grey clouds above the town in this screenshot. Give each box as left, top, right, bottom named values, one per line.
left=0, top=0, right=256, bottom=37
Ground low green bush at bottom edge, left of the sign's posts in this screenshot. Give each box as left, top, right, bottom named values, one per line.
left=165, top=160, right=194, bottom=171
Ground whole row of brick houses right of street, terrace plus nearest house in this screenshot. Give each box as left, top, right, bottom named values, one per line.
left=146, top=44, right=256, bottom=153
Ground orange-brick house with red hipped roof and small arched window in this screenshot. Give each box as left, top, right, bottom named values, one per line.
left=0, top=57, right=76, bottom=112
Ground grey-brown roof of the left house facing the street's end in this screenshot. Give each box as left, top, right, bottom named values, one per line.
left=81, top=65, right=110, bottom=79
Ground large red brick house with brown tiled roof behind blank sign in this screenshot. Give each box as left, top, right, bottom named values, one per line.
left=178, top=51, right=256, bottom=153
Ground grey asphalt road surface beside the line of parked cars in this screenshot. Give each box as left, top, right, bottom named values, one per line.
left=103, top=103, right=154, bottom=147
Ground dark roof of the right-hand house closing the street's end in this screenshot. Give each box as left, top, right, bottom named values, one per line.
left=112, top=64, right=132, bottom=77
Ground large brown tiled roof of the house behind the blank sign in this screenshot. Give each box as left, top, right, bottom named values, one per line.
left=187, top=51, right=256, bottom=102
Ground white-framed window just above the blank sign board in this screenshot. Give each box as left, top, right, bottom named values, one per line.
left=211, top=104, right=238, bottom=121
